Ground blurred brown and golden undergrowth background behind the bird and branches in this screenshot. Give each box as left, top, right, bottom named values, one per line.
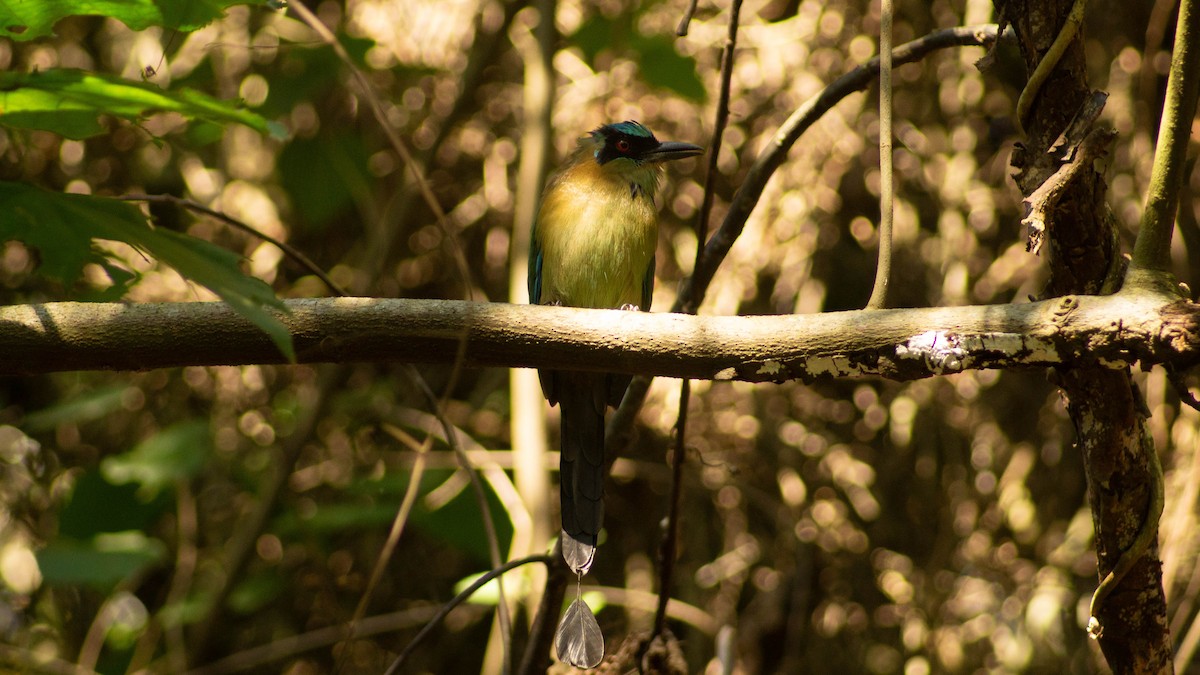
left=0, top=0, right=1200, bottom=675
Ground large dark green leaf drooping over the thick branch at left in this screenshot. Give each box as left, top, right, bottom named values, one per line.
left=0, top=178, right=295, bottom=360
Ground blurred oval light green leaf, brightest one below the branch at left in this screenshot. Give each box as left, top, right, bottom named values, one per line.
left=100, top=419, right=212, bottom=496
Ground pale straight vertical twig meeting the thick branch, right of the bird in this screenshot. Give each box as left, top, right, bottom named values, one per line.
left=866, top=0, right=895, bottom=310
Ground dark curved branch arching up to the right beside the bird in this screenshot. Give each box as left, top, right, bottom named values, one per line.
left=672, top=24, right=996, bottom=311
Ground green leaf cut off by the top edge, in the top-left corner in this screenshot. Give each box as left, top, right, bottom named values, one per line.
left=0, top=0, right=262, bottom=41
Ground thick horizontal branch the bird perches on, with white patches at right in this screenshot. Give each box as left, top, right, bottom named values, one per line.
left=0, top=289, right=1200, bottom=379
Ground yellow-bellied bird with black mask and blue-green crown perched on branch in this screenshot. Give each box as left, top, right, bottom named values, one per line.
left=528, top=120, right=703, bottom=575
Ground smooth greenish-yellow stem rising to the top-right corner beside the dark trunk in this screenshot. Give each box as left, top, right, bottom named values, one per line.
left=1129, top=0, right=1200, bottom=271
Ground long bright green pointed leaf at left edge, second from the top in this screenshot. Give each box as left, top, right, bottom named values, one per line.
left=0, top=68, right=286, bottom=138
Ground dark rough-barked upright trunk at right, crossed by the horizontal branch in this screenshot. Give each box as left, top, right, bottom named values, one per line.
left=996, top=0, right=1174, bottom=674
